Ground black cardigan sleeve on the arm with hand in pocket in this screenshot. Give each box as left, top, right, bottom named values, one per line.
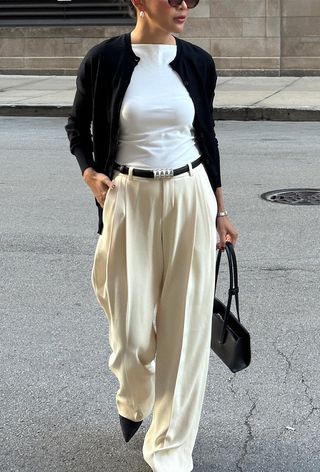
left=65, top=54, right=94, bottom=174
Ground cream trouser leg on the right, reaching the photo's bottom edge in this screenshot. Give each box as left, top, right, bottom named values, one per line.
left=143, top=165, right=217, bottom=472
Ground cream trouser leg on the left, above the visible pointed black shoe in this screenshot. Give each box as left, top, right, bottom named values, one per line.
left=92, top=172, right=163, bottom=421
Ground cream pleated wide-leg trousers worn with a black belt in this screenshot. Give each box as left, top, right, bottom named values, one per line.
left=92, top=160, right=217, bottom=472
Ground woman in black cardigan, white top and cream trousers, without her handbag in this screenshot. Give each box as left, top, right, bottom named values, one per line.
left=66, top=0, right=238, bottom=472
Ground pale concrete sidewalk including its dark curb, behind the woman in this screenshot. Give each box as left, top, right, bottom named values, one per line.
left=0, top=75, right=320, bottom=121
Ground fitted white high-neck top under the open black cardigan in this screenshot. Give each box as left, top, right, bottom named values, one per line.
left=116, top=44, right=201, bottom=169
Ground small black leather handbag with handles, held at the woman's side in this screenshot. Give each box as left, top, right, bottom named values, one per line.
left=211, top=242, right=251, bottom=372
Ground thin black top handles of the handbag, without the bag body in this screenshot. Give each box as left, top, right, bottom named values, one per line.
left=214, top=242, right=240, bottom=329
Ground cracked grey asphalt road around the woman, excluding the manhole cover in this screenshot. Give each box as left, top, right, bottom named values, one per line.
left=0, top=117, right=320, bottom=472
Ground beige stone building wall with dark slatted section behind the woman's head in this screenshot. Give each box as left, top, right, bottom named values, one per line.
left=0, top=0, right=320, bottom=76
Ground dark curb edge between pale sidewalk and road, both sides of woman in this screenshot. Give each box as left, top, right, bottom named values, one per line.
left=0, top=105, right=320, bottom=121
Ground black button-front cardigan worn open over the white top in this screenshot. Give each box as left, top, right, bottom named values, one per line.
left=65, top=33, right=221, bottom=234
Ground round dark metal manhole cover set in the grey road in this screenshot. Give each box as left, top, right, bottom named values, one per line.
left=261, top=188, right=320, bottom=205
